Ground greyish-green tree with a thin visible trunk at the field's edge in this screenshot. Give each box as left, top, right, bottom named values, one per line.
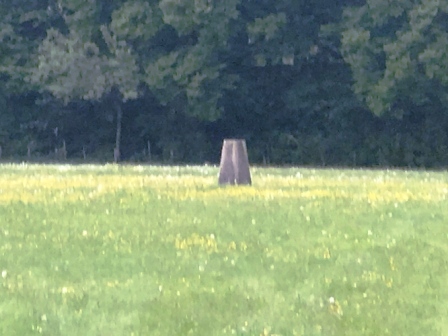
left=28, top=1, right=141, bottom=161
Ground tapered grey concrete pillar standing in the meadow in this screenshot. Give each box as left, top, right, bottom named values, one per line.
left=218, top=139, right=252, bottom=185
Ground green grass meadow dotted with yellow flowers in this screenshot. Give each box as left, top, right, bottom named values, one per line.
left=0, top=165, right=448, bottom=336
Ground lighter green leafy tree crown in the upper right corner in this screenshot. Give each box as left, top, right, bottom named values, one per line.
left=341, top=0, right=448, bottom=116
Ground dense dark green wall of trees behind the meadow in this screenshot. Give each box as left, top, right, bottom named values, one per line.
left=0, top=0, right=448, bottom=167
